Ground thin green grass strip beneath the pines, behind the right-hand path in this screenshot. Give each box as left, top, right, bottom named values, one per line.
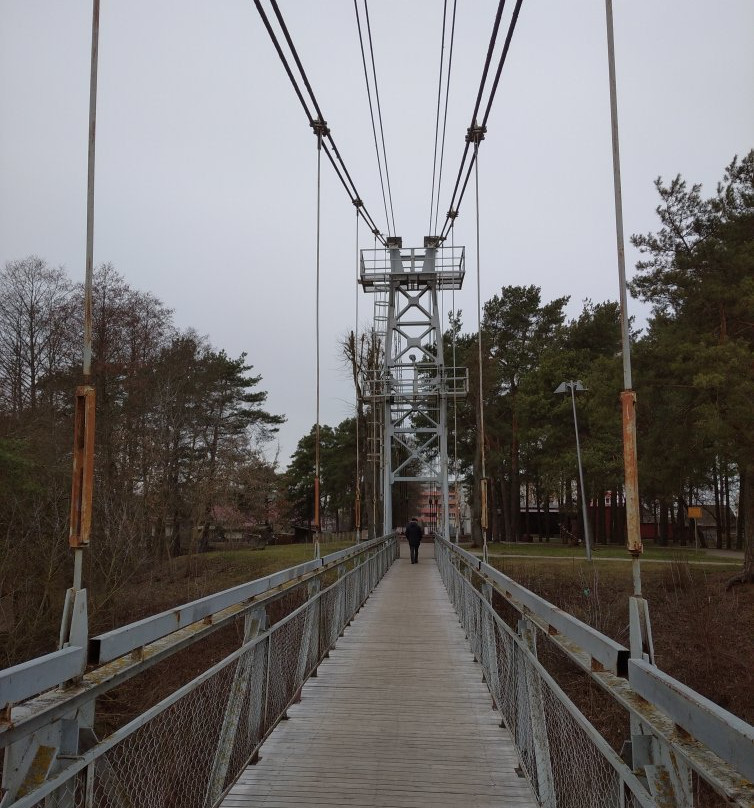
left=464, top=540, right=741, bottom=567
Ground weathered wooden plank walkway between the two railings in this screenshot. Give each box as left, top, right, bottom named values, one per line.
left=222, top=544, right=536, bottom=808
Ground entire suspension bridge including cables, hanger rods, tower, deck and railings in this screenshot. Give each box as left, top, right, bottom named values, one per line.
left=0, top=0, right=754, bottom=808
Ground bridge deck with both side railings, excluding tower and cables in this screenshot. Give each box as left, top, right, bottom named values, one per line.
left=0, top=535, right=754, bottom=808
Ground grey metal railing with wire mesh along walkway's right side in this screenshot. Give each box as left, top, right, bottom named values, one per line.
left=435, top=538, right=754, bottom=808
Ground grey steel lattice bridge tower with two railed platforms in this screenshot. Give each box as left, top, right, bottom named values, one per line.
left=359, top=236, right=468, bottom=539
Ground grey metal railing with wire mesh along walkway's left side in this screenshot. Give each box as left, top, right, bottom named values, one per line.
left=0, top=536, right=398, bottom=808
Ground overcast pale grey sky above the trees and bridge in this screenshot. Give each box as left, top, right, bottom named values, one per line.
left=0, top=0, right=754, bottom=463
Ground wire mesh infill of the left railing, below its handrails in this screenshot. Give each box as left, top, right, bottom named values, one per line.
left=2, top=537, right=397, bottom=808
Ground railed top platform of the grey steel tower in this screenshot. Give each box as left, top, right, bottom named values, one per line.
left=359, top=247, right=466, bottom=292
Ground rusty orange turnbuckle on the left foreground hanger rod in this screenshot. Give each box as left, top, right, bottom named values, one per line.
left=68, top=385, right=95, bottom=547
